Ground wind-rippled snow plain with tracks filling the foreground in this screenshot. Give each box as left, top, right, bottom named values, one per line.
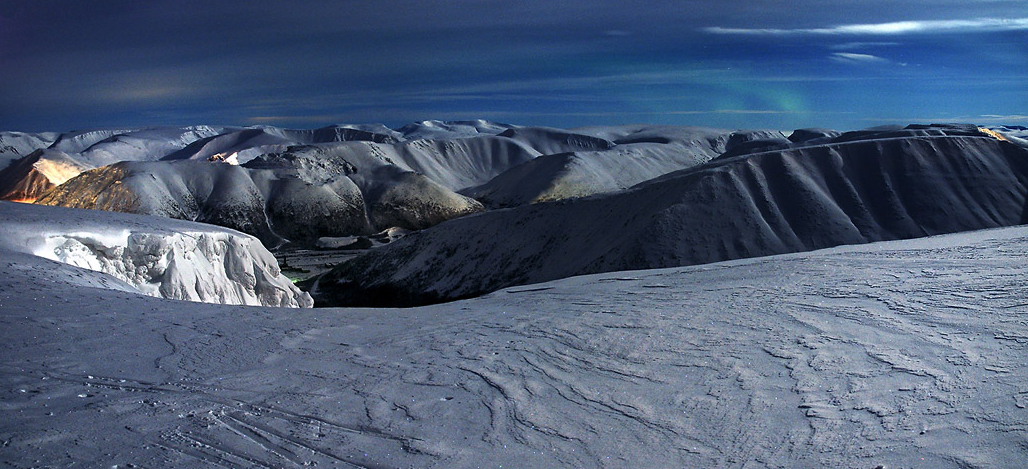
left=0, top=222, right=1028, bottom=469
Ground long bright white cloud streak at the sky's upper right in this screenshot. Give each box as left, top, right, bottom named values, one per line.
left=703, top=17, right=1028, bottom=36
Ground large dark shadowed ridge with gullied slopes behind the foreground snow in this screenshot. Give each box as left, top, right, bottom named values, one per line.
left=310, top=129, right=1028, bottom=305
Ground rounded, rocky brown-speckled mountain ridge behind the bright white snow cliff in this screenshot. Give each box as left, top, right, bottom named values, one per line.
left=37, top=156, right=481, bottom=247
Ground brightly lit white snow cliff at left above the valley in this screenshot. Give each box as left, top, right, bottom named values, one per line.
left=0, top=202, right=313, bottom=308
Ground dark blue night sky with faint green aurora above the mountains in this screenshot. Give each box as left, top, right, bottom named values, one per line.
left=0, top=0, right=1028, bottom=131
